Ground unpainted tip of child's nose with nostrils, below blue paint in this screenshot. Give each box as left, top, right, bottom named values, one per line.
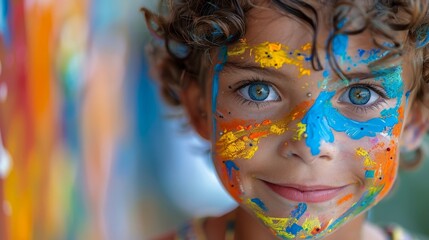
left=279, top=138, right=336, bottom=164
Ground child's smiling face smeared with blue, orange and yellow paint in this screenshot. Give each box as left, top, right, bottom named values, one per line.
left=201, top=3, right=411, bottom=239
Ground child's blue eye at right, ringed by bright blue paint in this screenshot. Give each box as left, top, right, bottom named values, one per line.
left=338, top=85, right=380, bottom=107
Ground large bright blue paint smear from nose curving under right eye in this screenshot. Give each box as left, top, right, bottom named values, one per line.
left=302, top=67, right=403, bottom=155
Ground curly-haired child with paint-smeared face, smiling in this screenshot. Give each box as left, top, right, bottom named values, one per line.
left=143, top=0, right=429, bottom=240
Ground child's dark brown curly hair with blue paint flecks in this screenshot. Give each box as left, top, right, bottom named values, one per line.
left=142, top=0, right=429, bottom=106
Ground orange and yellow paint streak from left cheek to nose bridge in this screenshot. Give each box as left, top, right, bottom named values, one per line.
left=215, top=101, right=312, bottom=160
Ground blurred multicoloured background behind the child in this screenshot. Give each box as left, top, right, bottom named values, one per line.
left=0, top=0, right=429, bottom=239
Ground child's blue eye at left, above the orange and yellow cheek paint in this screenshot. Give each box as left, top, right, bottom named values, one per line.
left=238, top=82, right=280, bottom=102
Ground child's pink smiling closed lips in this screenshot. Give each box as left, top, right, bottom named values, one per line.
left=264, top=181, right=347, bottom=203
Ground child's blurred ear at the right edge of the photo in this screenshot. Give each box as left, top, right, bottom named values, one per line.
left=401, top=101, right=429, bottom=151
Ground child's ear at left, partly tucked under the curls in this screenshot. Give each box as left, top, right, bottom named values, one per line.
left=181, top=81, right=210, bottom=140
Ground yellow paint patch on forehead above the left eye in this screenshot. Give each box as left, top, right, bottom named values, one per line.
left=228, top=39, right=311, bottom=77
